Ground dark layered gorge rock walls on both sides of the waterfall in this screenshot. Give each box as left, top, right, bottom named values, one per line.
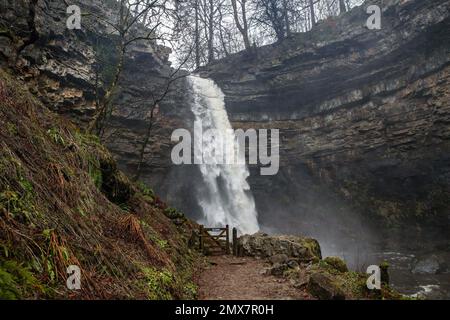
left=0, top=0, right=450, bottom=251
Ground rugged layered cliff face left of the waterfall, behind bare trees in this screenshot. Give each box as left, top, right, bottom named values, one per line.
left=0, top=0, right=189, bottom=200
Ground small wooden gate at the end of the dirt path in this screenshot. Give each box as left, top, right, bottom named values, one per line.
left=199, top=225, right=230, bottom=255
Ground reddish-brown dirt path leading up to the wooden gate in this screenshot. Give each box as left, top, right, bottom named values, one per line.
left=199, top=256, right=311, bottom=300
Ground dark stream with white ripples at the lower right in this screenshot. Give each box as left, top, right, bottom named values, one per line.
left=319, top=231, right=450, bottom=300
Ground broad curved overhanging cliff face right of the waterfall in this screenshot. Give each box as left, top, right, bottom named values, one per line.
left=201, top=0, right=450, bottom=244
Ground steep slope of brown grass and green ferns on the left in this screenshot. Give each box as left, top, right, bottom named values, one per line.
left=0, top=71, right=197, bottom=299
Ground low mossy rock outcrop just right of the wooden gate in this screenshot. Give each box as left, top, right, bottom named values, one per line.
left=239, top=232, right=322, bottom=265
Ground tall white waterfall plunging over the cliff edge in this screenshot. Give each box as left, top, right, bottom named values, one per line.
left=189, top=76, right=259, bottom=234
